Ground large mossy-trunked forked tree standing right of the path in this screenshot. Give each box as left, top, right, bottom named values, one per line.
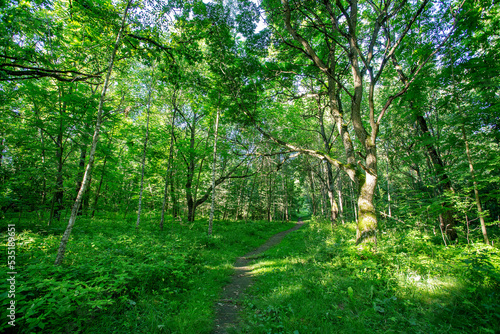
left=241, top=0, right=460, bottom=248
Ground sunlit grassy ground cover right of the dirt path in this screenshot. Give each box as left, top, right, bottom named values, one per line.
left=239, top=220, right=500, bottom=334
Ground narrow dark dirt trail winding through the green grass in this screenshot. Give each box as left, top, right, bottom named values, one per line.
left=213, top=221, right=304, bottom=334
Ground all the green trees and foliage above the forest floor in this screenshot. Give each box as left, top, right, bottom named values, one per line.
left=0, top=0, right=500, bottom=254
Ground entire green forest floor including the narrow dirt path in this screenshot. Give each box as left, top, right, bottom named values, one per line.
left=0, top=212, right=500, bottom=334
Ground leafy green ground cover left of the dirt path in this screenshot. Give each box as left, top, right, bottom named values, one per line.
left=0, top=215, right=293, bottom=333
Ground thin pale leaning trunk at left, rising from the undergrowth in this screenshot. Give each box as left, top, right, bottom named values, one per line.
left=54, top=0, right=133, bottom=265
